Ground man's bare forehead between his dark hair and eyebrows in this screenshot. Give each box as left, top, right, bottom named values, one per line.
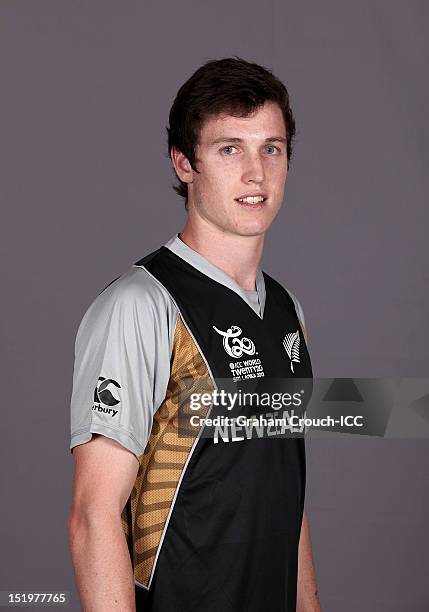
left=199, top=102, right=286, bottom=144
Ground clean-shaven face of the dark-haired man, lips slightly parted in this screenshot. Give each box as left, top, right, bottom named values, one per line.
left=188, top=102, right=287, bottom=236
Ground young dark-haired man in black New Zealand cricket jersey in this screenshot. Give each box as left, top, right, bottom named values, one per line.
left=69, top=58, right=320, bottom=612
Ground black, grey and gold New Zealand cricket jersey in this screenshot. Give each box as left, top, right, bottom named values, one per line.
left=70, top=235, right=313, bottom=612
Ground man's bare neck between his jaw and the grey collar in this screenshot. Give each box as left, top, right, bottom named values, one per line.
left=180, top=219, right=264, bottom=291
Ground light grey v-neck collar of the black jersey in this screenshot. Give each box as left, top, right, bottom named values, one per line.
left=164, top=234, right=266, bottom=319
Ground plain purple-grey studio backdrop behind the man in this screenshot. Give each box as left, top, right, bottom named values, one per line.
left=0, top=0, right=429, bottom=612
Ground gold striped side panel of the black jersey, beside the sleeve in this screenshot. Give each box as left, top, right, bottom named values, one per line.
left=121, top=316, right=213, bottom=586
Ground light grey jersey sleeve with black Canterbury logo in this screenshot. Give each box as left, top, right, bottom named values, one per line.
left=70, top=268, right=177, bottom=456
